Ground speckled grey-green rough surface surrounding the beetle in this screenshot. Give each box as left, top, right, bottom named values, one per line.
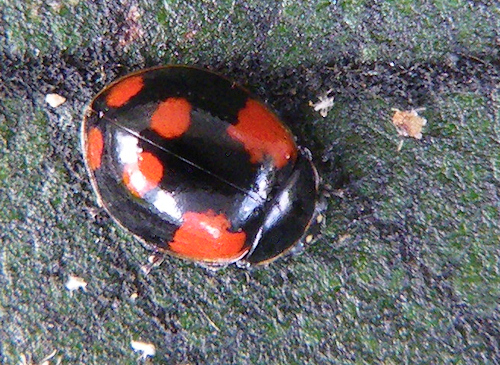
left=0, top=0, right=500, bottom=365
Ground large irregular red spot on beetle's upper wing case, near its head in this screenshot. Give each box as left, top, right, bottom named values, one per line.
left=227, top=99, right=297, bottom=168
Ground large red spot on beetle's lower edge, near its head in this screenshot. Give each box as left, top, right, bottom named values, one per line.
left=169, top=210, right=248, bottom=261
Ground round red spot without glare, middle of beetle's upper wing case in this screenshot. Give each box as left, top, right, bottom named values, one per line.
left=151, top=98, right=191, bottom=139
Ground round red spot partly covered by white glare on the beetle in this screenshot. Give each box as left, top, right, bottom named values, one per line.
left=123, top=152, right=164, bottom=197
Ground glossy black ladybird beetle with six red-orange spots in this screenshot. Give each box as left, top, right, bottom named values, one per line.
left=82, top=66, right=322, bottom=267
